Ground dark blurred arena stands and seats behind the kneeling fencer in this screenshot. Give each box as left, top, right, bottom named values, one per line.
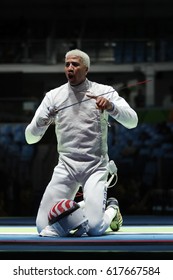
left=0, top=0, right=173, bottom=216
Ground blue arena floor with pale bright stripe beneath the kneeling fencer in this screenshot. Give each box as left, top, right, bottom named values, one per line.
left=0, top=216, right=173, bottom=255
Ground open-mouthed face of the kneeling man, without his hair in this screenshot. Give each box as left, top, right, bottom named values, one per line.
left=65, top=56, right=88, bottom=86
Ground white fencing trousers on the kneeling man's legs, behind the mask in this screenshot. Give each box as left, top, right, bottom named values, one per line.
left=36, top=156, right=114, bottom=235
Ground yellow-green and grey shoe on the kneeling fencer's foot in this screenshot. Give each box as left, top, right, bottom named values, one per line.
left=107, top=197, right=123, bottom=231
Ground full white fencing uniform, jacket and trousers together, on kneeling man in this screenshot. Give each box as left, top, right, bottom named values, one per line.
left=25, top=79, right=138, bottom=235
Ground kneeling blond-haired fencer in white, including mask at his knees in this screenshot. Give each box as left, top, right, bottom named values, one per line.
left=25, top=49, right=138, bottom=236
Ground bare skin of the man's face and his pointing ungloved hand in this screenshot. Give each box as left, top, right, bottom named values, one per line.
left=65, top=56, right=112, bottom=111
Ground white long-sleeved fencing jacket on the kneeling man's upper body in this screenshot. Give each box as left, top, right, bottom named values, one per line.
left=25, top=79, right=138, bottom=165
